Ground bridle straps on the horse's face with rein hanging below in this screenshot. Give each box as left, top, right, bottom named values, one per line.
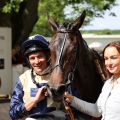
left=52, top=29, right=79, bottom=120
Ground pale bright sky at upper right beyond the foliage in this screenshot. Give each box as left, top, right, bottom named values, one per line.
left=83, top=0, right=120, bottom=30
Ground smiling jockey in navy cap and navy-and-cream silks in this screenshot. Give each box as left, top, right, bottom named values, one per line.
left=9, top=35, right=60, bottom=120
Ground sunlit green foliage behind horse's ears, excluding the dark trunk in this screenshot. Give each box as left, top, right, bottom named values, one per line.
left=32, top=0, right=115, bottom=36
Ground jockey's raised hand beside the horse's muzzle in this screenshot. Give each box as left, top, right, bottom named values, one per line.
left=35, top=86, right=47, bottom=102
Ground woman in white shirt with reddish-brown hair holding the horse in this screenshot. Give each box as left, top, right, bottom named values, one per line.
left=65, top=41, right=120, bottom=120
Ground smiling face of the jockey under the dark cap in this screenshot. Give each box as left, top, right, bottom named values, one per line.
left=28, top=52, right=47, bottom=74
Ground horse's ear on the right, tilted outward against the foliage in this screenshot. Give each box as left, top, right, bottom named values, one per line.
left=73, top=10, right=86, bottom=29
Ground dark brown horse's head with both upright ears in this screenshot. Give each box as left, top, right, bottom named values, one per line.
left=48, top=11, right=85, bottom=100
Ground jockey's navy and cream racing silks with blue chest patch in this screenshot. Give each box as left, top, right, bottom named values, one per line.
left=10, top=70, right=61, bottom=120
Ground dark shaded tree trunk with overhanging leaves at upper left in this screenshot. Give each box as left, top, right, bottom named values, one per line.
left=0, top=0, right=39, bottom=48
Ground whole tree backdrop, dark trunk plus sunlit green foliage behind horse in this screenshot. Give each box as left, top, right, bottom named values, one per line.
left=0, top=0, right=116, bottom=47
